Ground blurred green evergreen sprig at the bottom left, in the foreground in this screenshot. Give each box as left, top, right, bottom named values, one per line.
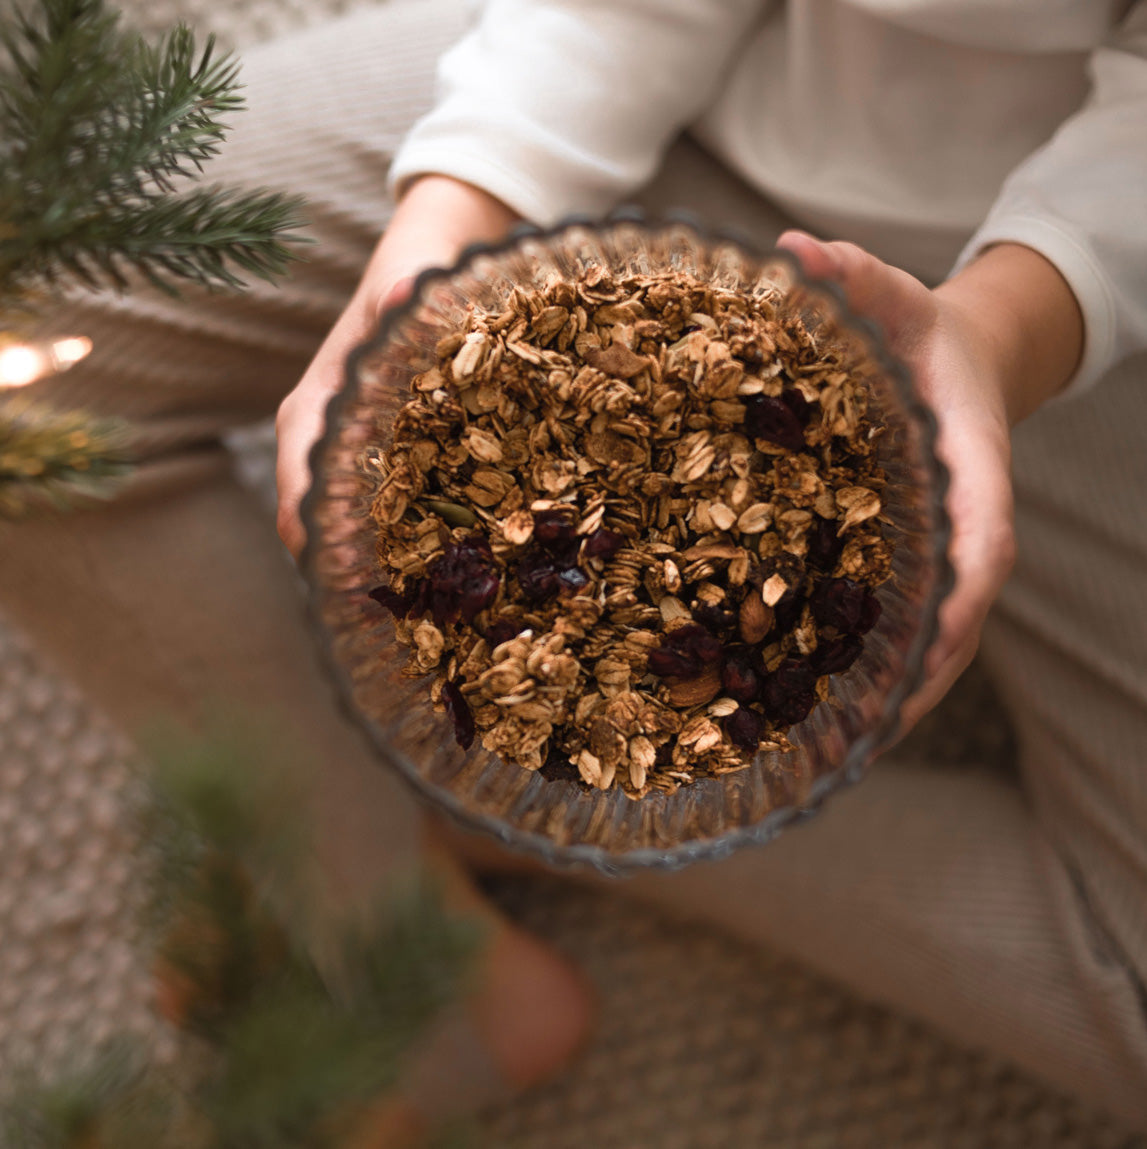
left=0, top=719, right=480, bottom=1149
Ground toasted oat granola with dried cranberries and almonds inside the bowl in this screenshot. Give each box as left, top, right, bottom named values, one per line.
left=363, top=267, right=892, bottom=797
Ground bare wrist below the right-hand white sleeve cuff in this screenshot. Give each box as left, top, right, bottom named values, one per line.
left=934, top=244, right=1084, bottom=426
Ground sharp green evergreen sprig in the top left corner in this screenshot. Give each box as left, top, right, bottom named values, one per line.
left=0, top=0, right=310, bottom=311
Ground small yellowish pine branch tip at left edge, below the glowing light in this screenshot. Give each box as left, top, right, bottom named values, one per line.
left=0, top=392, right=130, bottom=519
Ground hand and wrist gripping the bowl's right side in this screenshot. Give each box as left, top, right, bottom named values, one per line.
left=777, top=231, right=1083, bottom=732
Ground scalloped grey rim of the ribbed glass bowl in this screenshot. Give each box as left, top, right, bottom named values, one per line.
left=299, top=207, right=955, bottom=877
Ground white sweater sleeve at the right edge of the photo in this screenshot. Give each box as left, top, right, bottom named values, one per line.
left=957, top=0, right=1147, bottom=394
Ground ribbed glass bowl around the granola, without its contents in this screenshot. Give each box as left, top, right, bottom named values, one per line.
left=302, top=215, right=952, bottom=873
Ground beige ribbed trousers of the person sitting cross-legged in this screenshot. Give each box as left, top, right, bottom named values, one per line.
left=0, top=0, right=1147, bottom=1128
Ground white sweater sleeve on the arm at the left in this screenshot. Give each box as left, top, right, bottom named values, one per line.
left=391, top=0, right=763, bottom=224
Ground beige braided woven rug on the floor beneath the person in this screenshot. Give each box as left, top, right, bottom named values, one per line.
left=0, top=0, right=1147, bottom=1149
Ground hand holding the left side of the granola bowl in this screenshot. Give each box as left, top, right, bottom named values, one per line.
left=275, top=176, right=517, bottom=558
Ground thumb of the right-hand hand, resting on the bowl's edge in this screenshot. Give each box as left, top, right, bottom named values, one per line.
left=777, top=231, right=936, bottom=346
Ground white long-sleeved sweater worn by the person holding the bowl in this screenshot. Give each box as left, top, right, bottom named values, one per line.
left=392, top=0, right=1147, bottom=388
